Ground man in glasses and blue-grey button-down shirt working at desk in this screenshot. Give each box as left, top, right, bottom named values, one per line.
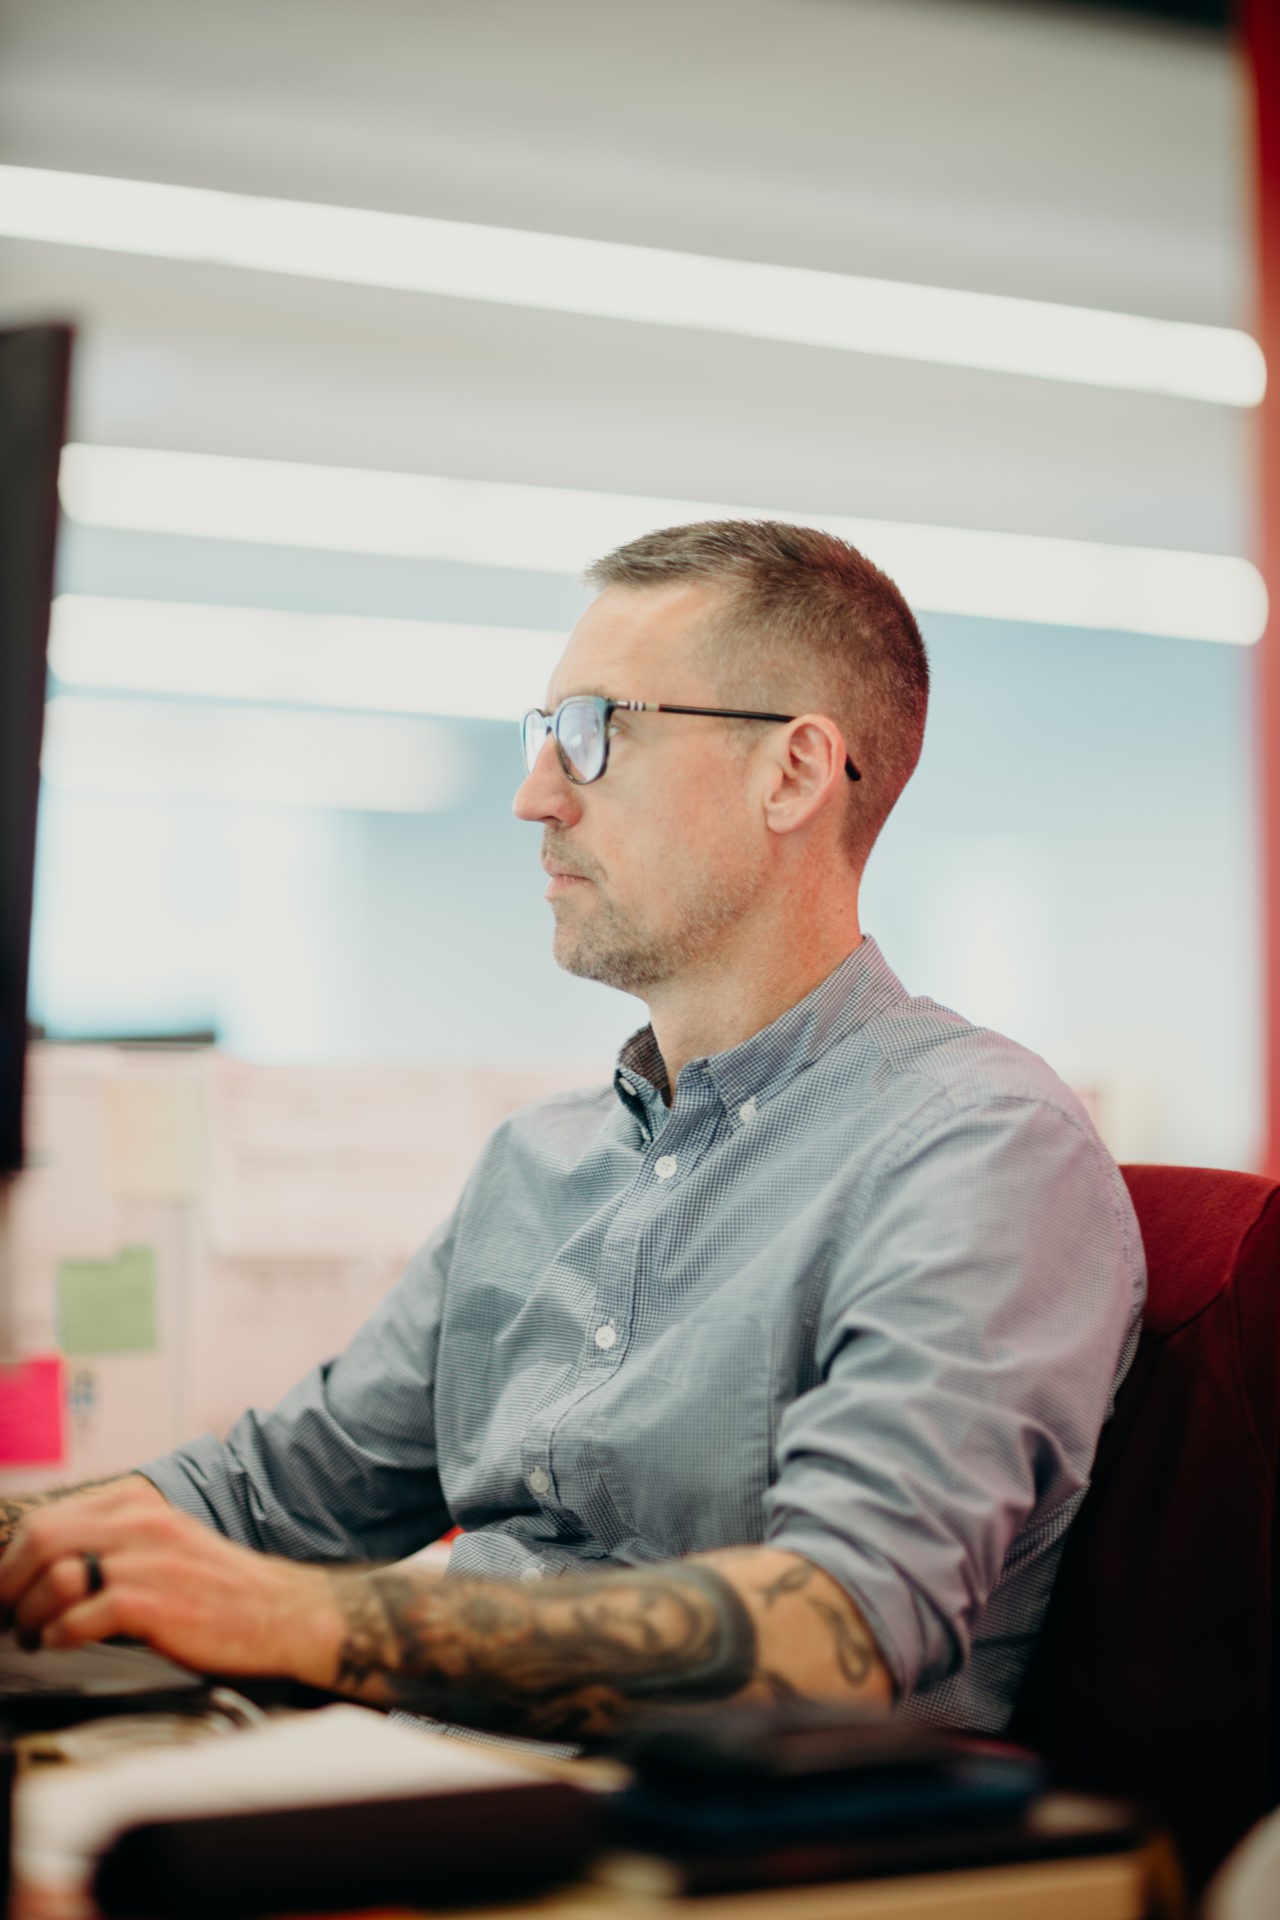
left=0, top=522, right=1144, bottom=1734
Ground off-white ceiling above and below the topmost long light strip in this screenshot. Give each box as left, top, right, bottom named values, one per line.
left=0, top=0, right=1251, bottom=553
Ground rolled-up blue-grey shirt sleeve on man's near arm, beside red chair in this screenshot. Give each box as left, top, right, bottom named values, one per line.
left=766, top=1098, right=1144, bottom=1693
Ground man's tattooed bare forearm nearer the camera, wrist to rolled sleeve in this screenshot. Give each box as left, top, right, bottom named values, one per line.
left=322, top=1548, right=892, bottom=1740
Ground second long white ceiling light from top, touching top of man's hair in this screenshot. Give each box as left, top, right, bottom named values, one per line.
left=61, top=445, right=1267, bottom=645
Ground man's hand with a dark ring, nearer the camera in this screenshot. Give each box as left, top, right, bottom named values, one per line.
left=0, top=1476, right=334, bottom=1676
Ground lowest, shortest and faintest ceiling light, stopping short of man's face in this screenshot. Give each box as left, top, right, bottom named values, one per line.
left=40, top=695, right=464, bottom=814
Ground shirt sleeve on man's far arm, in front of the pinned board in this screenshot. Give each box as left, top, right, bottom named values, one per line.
left=138, top=1215, right=457, bottom=1561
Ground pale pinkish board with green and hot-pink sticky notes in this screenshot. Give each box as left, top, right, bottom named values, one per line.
left=0, top=1044, right=604, bottom=1494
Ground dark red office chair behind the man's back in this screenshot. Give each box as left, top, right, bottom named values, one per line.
left=1009, top=1167, right=1280, bottom=1885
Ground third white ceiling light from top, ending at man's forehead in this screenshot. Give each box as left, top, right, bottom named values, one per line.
left=50, top=593, right=564, bottom=721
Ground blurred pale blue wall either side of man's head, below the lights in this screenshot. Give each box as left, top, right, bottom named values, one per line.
left=35, top=618, right=1261, bottom=1165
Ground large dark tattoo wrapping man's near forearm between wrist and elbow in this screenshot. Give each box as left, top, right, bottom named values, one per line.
left=330, top=1563, right=756, bottom=1736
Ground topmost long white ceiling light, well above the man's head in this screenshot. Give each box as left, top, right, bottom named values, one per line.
left=0, top=167, right=1267, bottom=407
